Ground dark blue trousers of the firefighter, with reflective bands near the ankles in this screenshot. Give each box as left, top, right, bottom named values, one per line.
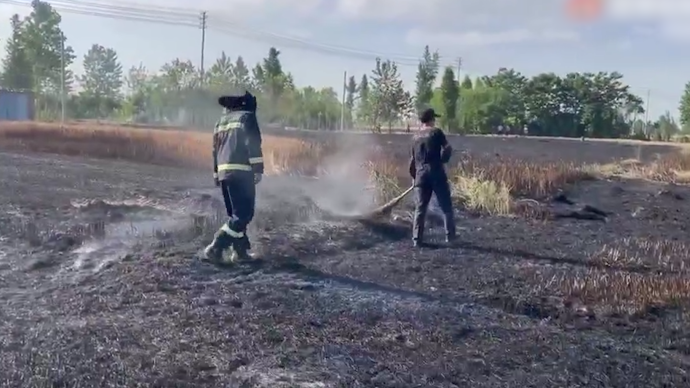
left=221, top=171, right=256, bottom=250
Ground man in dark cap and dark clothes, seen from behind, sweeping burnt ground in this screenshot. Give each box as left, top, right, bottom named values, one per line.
left=410, top=109, right=455, bottom=247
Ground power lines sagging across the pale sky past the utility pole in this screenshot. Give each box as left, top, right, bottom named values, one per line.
left=0, top=0, right=462, bottom=67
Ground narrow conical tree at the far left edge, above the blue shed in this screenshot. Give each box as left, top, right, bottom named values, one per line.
left=0, top=14, right=33, bottom=90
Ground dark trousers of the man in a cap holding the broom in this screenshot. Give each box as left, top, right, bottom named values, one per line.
left=412, top=176, right=455, bottom=241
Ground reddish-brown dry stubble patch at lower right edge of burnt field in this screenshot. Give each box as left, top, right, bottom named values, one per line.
left=533, top=238, right=690, bottom=315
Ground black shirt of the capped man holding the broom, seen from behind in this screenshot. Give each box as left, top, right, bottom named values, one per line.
left=410, top=128, right=451, bottom=177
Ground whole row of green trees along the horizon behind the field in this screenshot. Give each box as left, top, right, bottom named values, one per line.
left=0, top=0, right=690, bottom=138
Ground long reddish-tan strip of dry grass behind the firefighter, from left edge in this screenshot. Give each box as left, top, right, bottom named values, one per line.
left=0, top=123, right=322, bottom=173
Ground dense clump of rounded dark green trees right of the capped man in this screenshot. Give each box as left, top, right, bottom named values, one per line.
left=446, top=69, right=644, bottom=137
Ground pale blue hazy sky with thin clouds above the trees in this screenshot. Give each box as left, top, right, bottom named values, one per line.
left=0, top=0, right=690, bottom=119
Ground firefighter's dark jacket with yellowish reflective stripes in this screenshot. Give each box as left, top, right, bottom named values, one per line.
left=213, top=110, right=264, bottom=181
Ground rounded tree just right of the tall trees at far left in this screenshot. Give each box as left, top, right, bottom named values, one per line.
left=78, top=44, right=124, bottom=118
